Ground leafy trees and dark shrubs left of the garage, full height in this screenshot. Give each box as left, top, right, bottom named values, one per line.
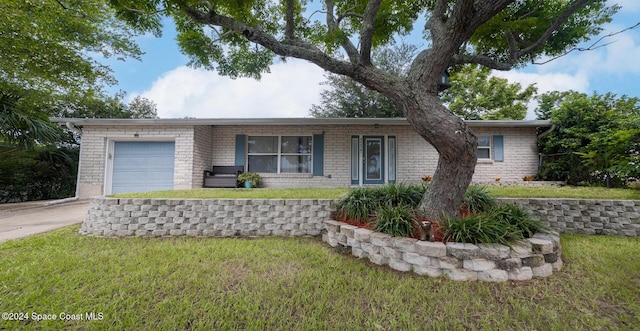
left=0, top=0, right=156, bottom=202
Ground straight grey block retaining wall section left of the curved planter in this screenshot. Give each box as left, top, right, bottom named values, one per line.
left=80, top=197, right=333, bottom=237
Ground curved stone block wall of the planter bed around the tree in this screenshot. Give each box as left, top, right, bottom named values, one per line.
left=322, top=220, right=562, bottom=282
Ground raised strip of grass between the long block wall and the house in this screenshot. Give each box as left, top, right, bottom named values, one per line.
left=113, top=185, right=640, bottom=200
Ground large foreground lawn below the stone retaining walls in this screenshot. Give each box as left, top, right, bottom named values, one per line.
left=0, top=226, right=640, bottom=330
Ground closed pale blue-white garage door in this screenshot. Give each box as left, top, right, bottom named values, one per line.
left=111, top=142, right=175, bottom=194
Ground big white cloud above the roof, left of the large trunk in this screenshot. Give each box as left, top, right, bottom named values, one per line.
left=140, top=59, right=324, bottom=118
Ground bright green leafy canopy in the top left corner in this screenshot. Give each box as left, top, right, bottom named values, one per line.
left=0, top=0, right=141, bottom=100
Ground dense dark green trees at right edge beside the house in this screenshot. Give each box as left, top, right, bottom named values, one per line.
left=538, top=91, right=640, bottom=187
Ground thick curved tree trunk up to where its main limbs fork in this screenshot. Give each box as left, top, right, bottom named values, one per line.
left=360, top=66, right=478, bottom=221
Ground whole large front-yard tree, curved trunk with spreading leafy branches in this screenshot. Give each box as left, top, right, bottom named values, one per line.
left=110, top=0, right=618, bottom=220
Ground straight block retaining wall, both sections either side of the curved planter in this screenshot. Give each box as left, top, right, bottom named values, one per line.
left=80, top=197, right=640, bottom=237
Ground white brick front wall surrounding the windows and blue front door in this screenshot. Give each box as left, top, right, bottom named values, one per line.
left=211, top=126, right=538, bottom=187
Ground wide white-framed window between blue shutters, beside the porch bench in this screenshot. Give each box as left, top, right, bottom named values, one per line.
left=247, top=136, right=313, bottom=174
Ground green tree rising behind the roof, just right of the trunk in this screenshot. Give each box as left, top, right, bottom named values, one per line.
left=442, top=64, right=537, bottom=120
